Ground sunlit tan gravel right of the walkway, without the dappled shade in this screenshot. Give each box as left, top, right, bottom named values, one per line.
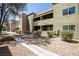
left=40, top=38, right=79, bottom=56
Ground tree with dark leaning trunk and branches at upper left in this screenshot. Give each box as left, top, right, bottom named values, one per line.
left=0, top=3, right=26, bottom=34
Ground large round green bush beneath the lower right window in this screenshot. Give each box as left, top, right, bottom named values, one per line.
left=61, top=31, right=74, bottom=41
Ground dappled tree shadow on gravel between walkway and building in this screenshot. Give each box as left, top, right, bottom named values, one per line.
left=16, top=35, right=50, bottom=45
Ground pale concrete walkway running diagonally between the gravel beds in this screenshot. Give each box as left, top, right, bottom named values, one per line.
left=16, top=38, right=59, bottom=56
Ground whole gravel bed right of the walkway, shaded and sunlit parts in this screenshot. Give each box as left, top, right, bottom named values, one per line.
left=14, top=35, right=79, bottom=56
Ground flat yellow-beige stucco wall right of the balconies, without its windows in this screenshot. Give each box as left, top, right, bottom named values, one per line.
left=53, top=3, right=79, bottom=38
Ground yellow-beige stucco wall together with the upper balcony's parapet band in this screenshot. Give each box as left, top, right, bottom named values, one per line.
left=34, top=3, right=79, bottom=38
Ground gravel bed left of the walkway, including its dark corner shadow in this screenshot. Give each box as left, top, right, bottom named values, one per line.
left=0, top=43, right=35, bottom=56
